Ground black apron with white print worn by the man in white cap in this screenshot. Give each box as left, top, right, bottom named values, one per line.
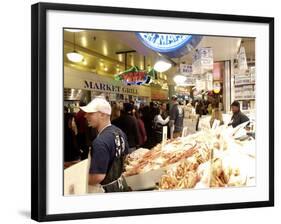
left=100, top=132, right=131, bottom=192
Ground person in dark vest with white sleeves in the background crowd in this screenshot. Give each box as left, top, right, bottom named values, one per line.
left=153, top=108, right=170, bottom=145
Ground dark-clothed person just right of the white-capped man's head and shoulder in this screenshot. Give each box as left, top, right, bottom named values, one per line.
left=112, top=103, right=139, bottom=153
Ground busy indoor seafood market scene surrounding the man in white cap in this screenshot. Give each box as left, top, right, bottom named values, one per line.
left=63, top=29, right=255, bottom=195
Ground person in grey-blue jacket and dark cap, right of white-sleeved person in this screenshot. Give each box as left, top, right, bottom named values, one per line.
left=169, top=96, right=184, bottom=138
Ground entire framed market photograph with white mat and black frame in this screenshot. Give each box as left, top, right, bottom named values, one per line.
left=31, top=3, right=274, bottom=221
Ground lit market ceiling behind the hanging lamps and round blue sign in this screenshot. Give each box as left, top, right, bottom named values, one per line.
left=64, top=30, right=255, bottom=78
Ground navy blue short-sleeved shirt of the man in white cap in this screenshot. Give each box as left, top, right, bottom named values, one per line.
left=89, top=125, right=129, bottom=174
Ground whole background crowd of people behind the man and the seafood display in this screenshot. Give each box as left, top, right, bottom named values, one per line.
left=64, top=96, right=247, bottom=165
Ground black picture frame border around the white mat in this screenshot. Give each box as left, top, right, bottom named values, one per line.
left=31, top=3, right=274, bottom=221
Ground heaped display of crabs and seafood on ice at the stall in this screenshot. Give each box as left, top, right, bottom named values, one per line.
left=124, top=124, right=255, bottom=190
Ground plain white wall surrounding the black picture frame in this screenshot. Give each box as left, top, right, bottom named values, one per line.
left=0, top=0, right=281, bottom=223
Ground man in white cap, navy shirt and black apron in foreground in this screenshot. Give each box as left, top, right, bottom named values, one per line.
left=80, top=97, right=128, bottom=192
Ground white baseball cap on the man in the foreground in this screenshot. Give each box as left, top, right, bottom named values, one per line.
left=80, top=97, right=111, bottom=115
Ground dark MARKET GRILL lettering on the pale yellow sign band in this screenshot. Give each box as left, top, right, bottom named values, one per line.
left=84, top=80, right=138, bottom=95
